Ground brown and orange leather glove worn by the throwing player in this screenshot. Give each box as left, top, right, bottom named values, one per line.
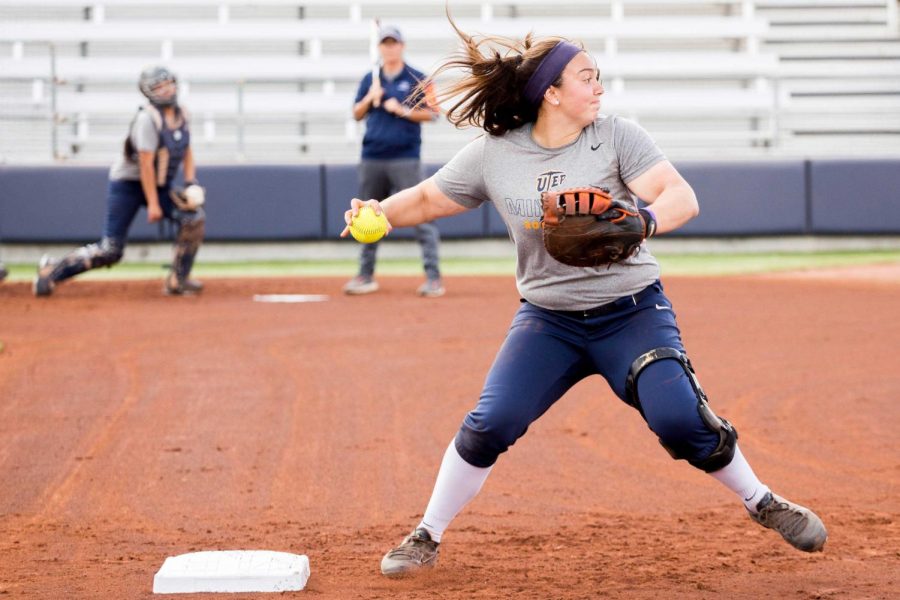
left=541, top=187, right=656, bottom=267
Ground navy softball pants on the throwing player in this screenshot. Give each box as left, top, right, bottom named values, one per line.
left=456, top=282, right=719, bottom=467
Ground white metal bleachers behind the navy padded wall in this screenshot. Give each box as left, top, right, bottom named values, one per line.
left=0, top=0, right=900, bottom=163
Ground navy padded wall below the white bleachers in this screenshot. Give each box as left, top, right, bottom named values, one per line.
left=0, top=159, right=900, bottom=243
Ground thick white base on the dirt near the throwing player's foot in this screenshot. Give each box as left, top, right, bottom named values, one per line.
left=153, top=550, right=309, bottom=594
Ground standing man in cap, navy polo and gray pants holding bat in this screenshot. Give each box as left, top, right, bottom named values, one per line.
left=344, top=25, right=444, bottom=298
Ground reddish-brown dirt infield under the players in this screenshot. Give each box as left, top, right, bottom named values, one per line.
left=0, top=273, right=900, bottom=600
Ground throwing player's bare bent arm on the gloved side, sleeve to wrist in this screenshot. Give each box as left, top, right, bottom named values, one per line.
left=628, top=160, right=700, bottom=234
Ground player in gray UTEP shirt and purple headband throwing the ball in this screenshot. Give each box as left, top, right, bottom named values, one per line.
left=345, top=20, right=827, bottom=576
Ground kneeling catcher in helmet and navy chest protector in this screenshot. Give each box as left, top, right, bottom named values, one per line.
left=33, top=66, right=206, bottom=296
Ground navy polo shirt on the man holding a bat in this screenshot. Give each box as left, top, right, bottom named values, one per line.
left=354, top=63, right=425, bottom=159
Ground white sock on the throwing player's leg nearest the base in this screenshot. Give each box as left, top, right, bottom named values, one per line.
left=418, top=441, right=493, bottom=542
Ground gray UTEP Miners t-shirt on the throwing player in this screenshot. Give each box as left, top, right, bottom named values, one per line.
left=434, top=115, right=665, bottom=310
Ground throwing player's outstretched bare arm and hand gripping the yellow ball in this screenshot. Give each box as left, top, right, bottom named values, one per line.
left=341, top=177, right=468, bottom=237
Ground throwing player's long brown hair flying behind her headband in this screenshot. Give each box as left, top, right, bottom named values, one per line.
left=425, top=10, right=583, bottom=135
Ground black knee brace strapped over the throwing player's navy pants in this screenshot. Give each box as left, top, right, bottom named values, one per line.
left=625, top=348, right=738, bottom=473
